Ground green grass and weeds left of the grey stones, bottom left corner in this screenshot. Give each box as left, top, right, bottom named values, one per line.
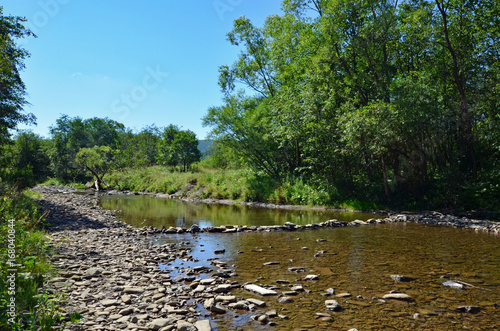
left=0, top=187, right=59, bottom=331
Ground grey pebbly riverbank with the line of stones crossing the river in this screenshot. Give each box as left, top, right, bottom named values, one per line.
left=34, top=186, right=500, bottom=331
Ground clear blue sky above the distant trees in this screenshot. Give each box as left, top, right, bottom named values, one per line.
left=0, top=0, right=281, bottom=139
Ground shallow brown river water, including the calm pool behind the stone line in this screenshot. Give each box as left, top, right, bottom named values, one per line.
left=101, top=196, right=500, bottom=331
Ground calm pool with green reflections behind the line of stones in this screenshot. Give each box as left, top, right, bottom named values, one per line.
left=100, top=195, right=380, bottom=228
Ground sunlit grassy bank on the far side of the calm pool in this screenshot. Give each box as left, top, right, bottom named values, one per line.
left=105, top=166, right=378, bottom=209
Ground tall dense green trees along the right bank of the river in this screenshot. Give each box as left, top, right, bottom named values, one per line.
left=203, top=0, right=500, bottom=208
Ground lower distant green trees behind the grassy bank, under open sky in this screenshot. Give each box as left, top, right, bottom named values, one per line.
left=0, top=115, right=201, bottom=187
